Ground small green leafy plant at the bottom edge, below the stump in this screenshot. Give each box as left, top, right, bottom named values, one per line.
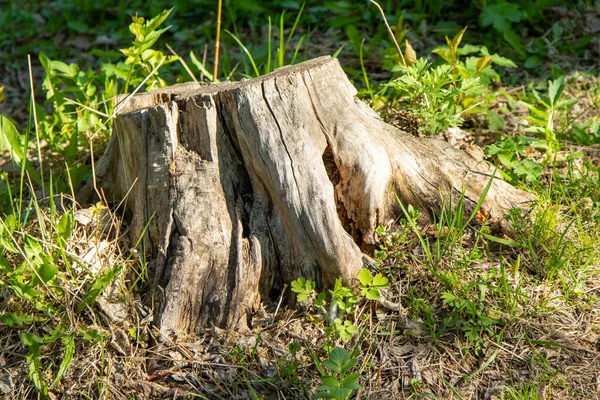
left=315, top=347, right=362, bottom=400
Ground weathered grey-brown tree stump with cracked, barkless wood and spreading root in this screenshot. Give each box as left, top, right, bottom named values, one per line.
left=87, top=57, right=530, bottom=333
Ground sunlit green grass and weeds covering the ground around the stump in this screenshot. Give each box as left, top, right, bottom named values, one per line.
left=0, top=0, right=600, bottom=399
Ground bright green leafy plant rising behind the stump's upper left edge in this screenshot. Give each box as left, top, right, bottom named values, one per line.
left=30, top=10, right=178, bottom=164
